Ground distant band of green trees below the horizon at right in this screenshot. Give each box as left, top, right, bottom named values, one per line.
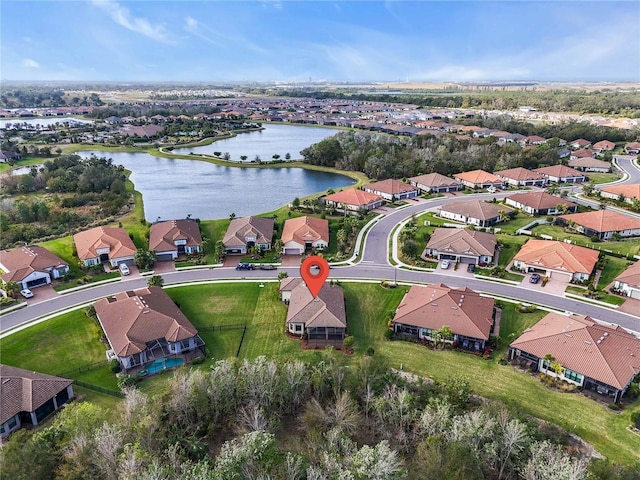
left=272, top=88, right=640, bottom=118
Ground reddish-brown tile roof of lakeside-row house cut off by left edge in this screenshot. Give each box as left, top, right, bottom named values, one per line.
left=0, top=245, right=68, bottom=282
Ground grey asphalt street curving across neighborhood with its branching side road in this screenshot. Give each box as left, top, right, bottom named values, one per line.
left=0, top=159, right=640, bottom=336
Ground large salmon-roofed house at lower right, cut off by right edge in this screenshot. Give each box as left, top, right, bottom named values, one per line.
left=509, top=312, right=640, bottom=402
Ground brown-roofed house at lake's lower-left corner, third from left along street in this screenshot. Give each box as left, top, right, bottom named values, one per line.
left=149, top=218, right=202, bottom=261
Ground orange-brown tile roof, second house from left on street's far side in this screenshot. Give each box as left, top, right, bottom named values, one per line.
left=73, top=227, right=136, bottom=260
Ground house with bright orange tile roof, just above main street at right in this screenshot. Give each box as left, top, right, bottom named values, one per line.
left=513, top=238, right=599, bottom=281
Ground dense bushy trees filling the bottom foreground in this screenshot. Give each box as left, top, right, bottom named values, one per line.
left=2, top=358, right=606, bottom=480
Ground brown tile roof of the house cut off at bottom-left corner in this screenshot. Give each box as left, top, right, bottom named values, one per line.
left=0, top=365, right=73, bottom=424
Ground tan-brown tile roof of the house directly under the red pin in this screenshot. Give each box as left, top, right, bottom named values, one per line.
left=287, top=282, right=347, bottom=328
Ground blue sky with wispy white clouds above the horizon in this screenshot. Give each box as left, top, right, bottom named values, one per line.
left=0, top=0, right=640, bottom=82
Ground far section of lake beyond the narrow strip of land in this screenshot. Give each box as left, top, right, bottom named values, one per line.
left=173, top=124, right=340, bottom=162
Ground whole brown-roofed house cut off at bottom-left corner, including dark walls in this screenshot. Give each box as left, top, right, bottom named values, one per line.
left=0, top=365, right=73, bottom=438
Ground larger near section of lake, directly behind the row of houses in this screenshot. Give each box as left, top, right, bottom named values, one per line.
left=78, top=150, right=355, bottom=222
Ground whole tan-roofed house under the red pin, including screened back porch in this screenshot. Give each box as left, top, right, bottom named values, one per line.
left=281, top=278, right=347, bottom=346
